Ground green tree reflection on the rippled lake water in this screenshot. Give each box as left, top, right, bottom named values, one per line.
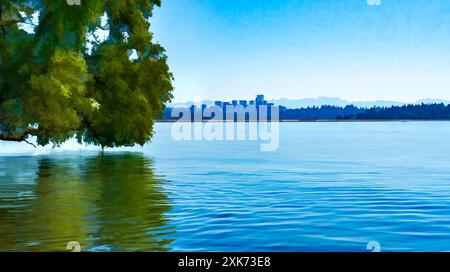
left=0, top=153, right=174, bottom=251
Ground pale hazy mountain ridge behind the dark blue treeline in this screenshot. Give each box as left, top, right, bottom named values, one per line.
left=169, top=96, right=450, bottom=109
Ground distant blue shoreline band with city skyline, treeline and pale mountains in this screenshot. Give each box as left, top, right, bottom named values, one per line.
left=162, top=94, right=450, bottom=121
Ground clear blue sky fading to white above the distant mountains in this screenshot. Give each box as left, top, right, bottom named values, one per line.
left=152, top=0, right=450, bottom=102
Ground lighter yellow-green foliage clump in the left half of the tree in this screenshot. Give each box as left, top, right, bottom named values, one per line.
left=28, top=51, right=91, bottom=145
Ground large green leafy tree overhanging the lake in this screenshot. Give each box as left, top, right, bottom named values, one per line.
left=0, top=0, right=173, bottom=147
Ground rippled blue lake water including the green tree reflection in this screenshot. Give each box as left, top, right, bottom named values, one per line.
left=0, top=122, right=450, bottom=251
